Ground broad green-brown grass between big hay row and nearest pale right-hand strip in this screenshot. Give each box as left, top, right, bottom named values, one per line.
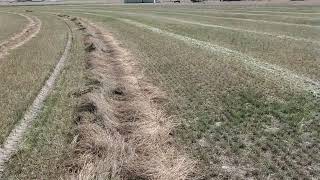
left=60, top=12, right=319, bottom=178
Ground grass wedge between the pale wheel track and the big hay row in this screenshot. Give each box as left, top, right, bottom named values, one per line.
left=3, top=19, right=86, bottom=179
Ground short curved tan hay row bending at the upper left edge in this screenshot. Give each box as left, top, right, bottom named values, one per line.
left=0, top=13, right=41, bottom=59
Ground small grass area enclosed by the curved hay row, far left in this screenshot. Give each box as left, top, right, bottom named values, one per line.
left=0, top=12, right=28, bottom=43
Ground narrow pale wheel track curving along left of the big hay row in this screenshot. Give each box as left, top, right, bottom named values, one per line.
left=0, top=22, right=72, bottom=178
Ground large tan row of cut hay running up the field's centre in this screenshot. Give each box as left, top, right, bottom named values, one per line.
left=66, top=16, right=193, bottom=180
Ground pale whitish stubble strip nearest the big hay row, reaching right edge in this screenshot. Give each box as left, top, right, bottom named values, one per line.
left=80, top=13, right=320, bottom=97
